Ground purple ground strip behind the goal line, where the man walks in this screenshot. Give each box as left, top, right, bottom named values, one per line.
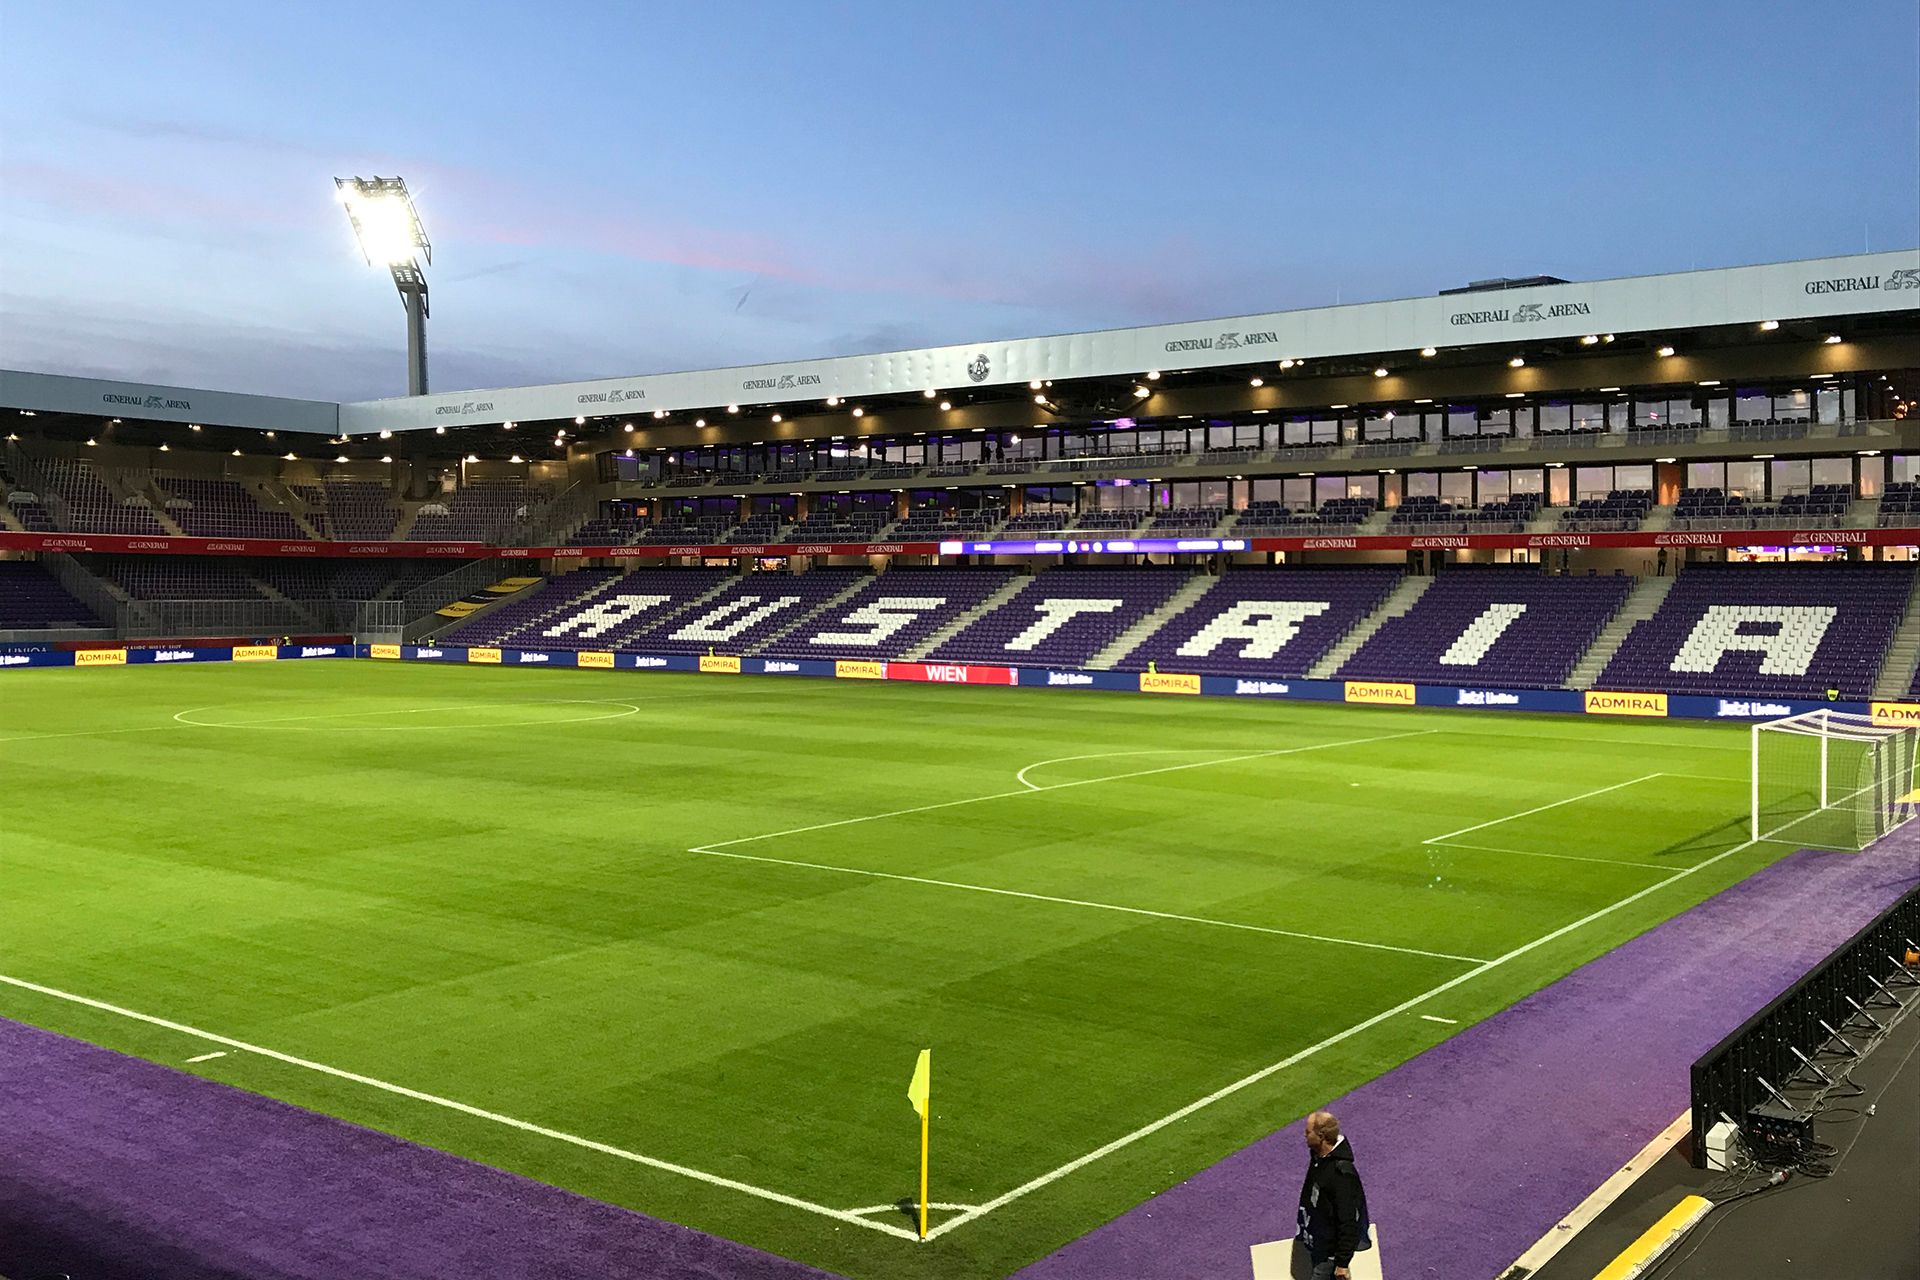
left=1016, top=829, right=1920, bottom=1280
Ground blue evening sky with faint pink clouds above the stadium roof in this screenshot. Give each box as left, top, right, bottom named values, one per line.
left=0, top=0, right=1920, bottom=399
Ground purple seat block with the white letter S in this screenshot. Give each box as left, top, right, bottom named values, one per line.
left=762, top=568, right=1016, bottom=660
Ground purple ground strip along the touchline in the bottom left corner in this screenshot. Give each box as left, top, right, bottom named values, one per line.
left=0, top=1019, right=848, bottom=1280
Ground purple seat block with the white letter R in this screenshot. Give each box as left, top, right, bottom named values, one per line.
left=1116, top=568, right=1402, bottom=677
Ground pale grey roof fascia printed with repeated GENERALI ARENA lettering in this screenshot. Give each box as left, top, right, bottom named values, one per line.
left=0, top=249, right=1920, bottom=436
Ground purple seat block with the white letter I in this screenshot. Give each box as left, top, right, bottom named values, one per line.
left=1340, top=566, right=1634, bottom=689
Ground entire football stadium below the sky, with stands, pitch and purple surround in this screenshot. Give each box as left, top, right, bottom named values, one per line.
left=0, top=251, right=1920, bottom=1280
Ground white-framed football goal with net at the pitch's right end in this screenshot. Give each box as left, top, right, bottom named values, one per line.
left=1751, top=710, right=1920, bottom=850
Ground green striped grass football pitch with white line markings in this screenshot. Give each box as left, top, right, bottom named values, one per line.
left=0, top=662, right=1786, bottom=1280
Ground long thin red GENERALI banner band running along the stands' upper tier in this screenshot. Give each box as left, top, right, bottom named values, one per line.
left=0, top=528, right=1920, bottom=560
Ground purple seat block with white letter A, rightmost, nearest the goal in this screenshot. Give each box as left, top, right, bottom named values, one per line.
left=1596, top=564, right=1914, bottom=699
